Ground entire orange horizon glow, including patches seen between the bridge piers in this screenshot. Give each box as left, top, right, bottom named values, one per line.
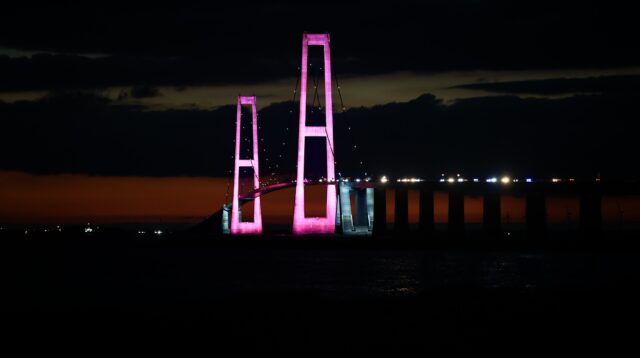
left=0, top=171, right=640, bottom=225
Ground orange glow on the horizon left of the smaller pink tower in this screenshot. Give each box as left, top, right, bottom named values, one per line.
left=0, top=172, right=227, bottom=224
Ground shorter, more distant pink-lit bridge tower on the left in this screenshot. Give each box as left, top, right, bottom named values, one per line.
left=231, top=96, right=262, bottom=234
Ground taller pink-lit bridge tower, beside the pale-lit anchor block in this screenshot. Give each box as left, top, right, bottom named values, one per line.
left=293, top=33, right=336, bottom=235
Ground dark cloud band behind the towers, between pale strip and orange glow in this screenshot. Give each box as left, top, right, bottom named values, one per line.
left=0, top=89, right=640, bottom=178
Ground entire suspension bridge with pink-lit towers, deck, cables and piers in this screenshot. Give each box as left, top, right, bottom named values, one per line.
left=212, top=33, right=640, bottom=235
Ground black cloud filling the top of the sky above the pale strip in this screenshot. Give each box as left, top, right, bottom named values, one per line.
left=0, top=0, right=640, bottom=90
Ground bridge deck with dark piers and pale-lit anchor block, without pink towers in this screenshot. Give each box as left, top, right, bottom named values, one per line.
left=216, top=181, right=640, bottom=237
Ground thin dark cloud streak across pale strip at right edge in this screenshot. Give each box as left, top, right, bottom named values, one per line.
left=453, top=76, right=640, bottom=95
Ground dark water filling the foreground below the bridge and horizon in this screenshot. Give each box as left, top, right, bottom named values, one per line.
left=1, top=236, right=640, bottom=357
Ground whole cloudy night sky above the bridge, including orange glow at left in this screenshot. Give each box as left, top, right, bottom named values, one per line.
left=0, top=0, right=640, bottom=223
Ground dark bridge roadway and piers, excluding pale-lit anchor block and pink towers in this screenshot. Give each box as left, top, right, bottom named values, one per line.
left=214, top=181, right=640, bottom=236
